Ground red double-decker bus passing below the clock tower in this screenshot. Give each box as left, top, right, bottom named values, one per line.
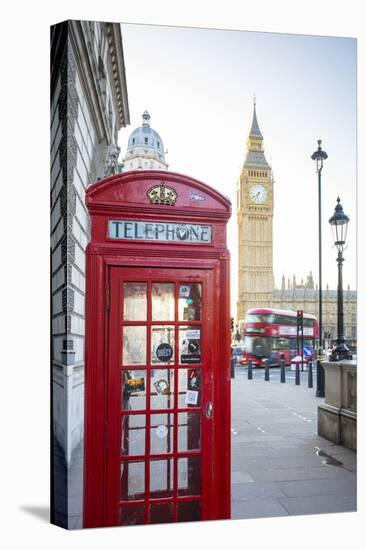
left=238, top=308, right=319, bottom=366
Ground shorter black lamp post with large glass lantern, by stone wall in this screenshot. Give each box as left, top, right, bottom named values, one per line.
left=329, top=197, right=352, bottom=361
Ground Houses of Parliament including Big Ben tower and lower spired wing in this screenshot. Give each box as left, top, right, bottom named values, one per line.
left=237, top=103, right=357, bottom=348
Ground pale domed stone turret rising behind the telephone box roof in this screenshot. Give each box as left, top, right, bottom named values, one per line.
left=122, top=111, right=169, bottom=172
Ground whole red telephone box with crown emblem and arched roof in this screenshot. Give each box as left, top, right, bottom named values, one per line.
left=84, top=171, right=231, bottom=527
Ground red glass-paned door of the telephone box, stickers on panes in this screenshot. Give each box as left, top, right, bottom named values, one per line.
left=106, top=267, right=215, bottom=525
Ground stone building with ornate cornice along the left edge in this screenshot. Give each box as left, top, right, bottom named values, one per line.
left=50, top=21, right=129, bottom=528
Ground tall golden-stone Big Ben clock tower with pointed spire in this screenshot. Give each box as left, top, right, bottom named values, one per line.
left=237, top=102, right=274, bottom=319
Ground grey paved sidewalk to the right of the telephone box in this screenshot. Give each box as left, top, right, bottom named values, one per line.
left=231, top=366, right=356, bottom=519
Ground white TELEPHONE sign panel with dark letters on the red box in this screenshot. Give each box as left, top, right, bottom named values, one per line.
left=108, top=220, right=212, bottom=244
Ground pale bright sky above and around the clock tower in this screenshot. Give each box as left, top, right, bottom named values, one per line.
left=120, top=24, right=356, bottom=312
